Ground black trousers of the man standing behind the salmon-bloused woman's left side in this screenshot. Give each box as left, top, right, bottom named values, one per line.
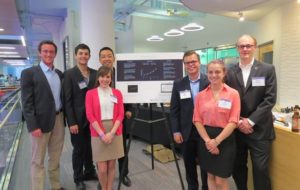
left=182, top=127, right=208, bottom=190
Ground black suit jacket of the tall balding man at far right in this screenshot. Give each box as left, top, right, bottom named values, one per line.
left=227, top=60, right=277, bottom=140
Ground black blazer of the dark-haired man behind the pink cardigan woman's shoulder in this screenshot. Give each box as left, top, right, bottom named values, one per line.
left=63, top=66, right=97, bottom=128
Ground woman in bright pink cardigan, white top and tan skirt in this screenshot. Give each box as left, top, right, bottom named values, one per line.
left=85, top=66, right=124, bottom=190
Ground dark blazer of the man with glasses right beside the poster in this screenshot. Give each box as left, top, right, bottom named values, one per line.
left=170, top=73, right=209, bottom=141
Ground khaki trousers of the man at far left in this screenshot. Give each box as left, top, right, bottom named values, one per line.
left=31, top=113, right=65, bottom=190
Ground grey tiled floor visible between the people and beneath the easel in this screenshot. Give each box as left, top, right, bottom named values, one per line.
left=9, top=125, right=236, bottom=190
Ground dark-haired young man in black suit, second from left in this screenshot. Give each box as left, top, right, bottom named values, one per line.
left=63, top=44, right=98, bottom=190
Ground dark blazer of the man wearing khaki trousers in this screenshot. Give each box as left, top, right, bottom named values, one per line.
left=21, top=65, right=63, bottom=133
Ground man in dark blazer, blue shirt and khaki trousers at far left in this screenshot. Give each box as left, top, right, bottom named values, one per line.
left=21, top=40, right=65, bottom=190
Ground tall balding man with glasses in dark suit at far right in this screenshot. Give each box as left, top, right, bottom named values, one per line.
left=227, top=35, right=277, bottom=190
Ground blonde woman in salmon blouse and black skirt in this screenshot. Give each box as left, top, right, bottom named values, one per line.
left=193, top=60, right=241, bottom=190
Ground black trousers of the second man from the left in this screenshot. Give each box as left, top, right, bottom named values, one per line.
left=71, top=126, right=95, bottom=183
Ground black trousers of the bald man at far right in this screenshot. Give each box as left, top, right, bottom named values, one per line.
left=233, top=132, right=272, bottom=190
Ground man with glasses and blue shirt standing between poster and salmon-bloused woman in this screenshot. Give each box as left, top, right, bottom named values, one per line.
left=170, top=51, right=209, bottom=190
